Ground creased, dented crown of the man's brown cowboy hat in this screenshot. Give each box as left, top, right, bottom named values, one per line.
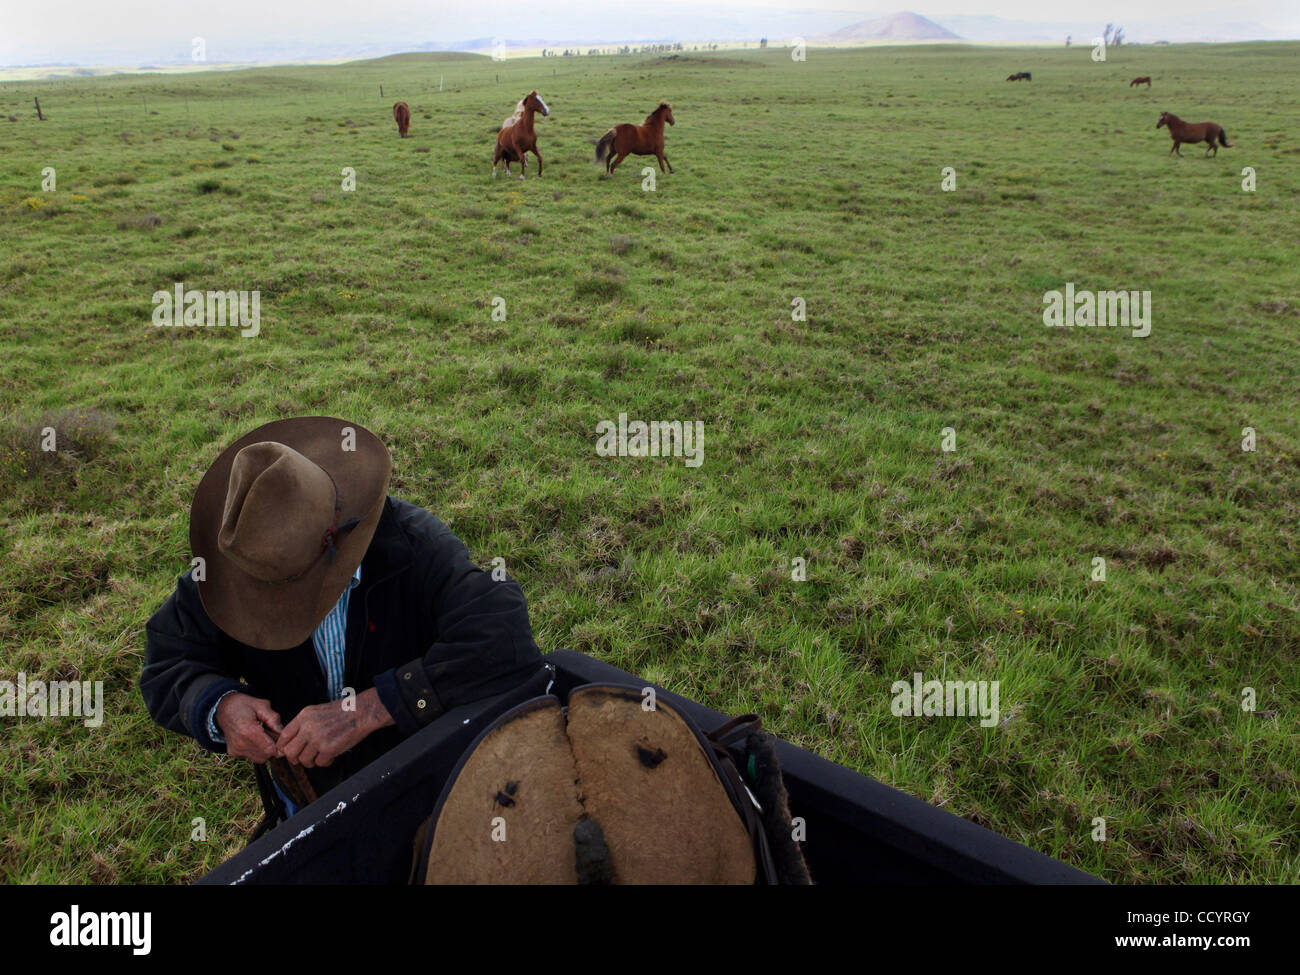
left=217, top=441, right=339, bottom=582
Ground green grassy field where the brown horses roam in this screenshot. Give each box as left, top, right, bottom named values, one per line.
left=0, top=44, right=1300, bottom=883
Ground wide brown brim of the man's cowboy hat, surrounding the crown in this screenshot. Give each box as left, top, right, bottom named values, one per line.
left=190, top=416, right=393, bottom=650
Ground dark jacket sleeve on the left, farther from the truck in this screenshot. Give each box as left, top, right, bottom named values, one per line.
left=140, top=572, right=255, bottom=753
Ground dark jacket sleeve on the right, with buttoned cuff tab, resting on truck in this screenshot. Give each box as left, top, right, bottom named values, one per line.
left=374, top=506, right=542, bottom=735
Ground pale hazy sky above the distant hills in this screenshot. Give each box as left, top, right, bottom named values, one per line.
left=0, top=0, right=1300, bottom=65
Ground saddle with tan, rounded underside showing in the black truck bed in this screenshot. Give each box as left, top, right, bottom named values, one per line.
left=412, top=684, right=811, bottom=884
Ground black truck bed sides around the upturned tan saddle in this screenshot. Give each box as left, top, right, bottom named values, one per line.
left=198, top=650, right=1104, bottom=884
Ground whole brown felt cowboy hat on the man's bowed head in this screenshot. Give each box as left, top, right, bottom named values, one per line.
left=190, top=416, right=393, bottom=650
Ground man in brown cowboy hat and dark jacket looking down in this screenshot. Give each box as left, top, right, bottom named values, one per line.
left=140, top=416, right=542, bottom=814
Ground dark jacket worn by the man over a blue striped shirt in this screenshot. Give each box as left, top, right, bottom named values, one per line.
left=140, top=498, right=542, bottom=793
